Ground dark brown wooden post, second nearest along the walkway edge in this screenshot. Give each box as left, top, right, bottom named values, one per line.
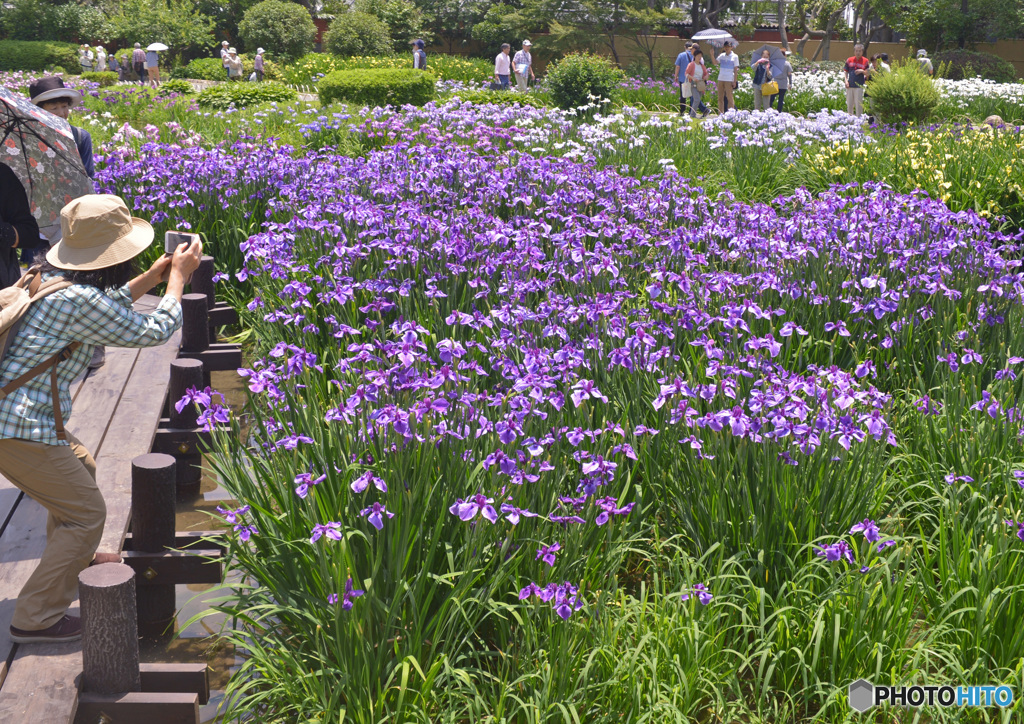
left=131, top=453, right=177, bottom=638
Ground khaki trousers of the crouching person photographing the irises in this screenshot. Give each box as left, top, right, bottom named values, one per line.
left=0, top=432, right=106, bottom=631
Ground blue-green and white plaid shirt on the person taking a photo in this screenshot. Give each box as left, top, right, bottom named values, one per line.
left=0, top=278, right=181, bottom=444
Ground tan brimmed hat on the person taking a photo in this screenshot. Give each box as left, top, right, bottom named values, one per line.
left=46, top=194, right=154, bottom=271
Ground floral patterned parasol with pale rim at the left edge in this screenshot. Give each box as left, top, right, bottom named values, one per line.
left=0, top=88, right=93, bottom=226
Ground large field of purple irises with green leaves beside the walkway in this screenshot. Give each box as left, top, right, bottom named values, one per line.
left=6, top=65, right=1024, bottom=724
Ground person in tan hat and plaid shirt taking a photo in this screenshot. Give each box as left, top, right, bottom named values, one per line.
left=0, top=194, right=203, bottom=644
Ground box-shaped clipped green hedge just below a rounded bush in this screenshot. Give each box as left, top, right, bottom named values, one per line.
left=316, top=69, right=437, bottom=105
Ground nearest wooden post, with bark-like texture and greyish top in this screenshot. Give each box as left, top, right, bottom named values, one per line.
left=78, top=563, right=142, bottom=694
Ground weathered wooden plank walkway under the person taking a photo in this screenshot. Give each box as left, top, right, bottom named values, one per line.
left=0, top=295, right=180, bottom=724
